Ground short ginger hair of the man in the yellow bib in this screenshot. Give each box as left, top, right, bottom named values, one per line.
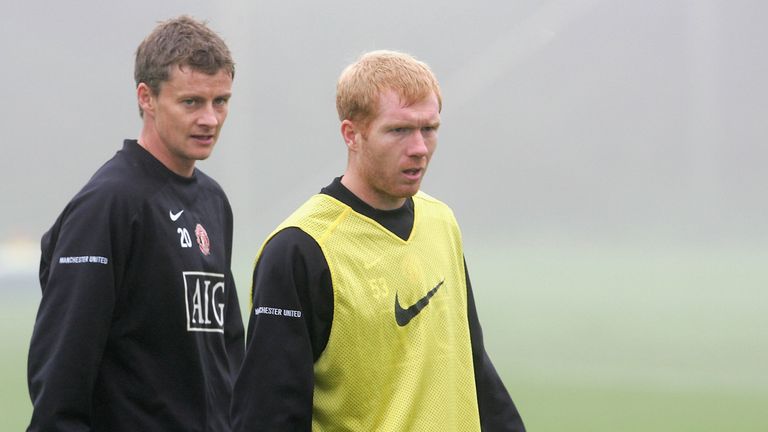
left=336, top=50, right=443, bottom=127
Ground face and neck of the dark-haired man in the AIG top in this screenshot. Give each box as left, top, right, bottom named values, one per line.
left=144, top=67, right=232, bottom=175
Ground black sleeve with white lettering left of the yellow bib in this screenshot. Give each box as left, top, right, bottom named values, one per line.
left=232, top=228, right=333, bottom=432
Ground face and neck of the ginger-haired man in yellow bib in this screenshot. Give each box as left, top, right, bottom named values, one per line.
left=350, top=91, right=440, bottom=210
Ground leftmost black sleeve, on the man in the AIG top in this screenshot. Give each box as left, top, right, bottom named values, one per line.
left=27, top=192, right=130, bottom=431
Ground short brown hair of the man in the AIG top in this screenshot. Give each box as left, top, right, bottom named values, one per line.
left=133, top=15, right=235, bottom=115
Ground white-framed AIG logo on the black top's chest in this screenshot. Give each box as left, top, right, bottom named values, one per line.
left=183, top=272, right=227, bottom=333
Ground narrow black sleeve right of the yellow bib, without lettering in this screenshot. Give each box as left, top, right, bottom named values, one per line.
left=464, top=262, right=525, bottom=432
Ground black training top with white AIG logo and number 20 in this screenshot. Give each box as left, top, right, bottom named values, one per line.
left=28, top=140, right=243, bottom=432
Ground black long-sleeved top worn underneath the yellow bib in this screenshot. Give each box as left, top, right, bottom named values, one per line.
left=232, top=177, right=525, bottom=432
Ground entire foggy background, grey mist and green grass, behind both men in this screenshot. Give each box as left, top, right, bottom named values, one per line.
left=0, top=0, right=768, bottom=431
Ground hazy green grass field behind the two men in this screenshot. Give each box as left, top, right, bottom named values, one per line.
left=0, top=241, right=768, bottom=432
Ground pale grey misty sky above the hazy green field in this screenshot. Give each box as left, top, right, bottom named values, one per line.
left=0, top=0, right=768, bottom=264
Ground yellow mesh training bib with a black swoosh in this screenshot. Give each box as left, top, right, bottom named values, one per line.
left=278, top=192, right=480, bottom=432
